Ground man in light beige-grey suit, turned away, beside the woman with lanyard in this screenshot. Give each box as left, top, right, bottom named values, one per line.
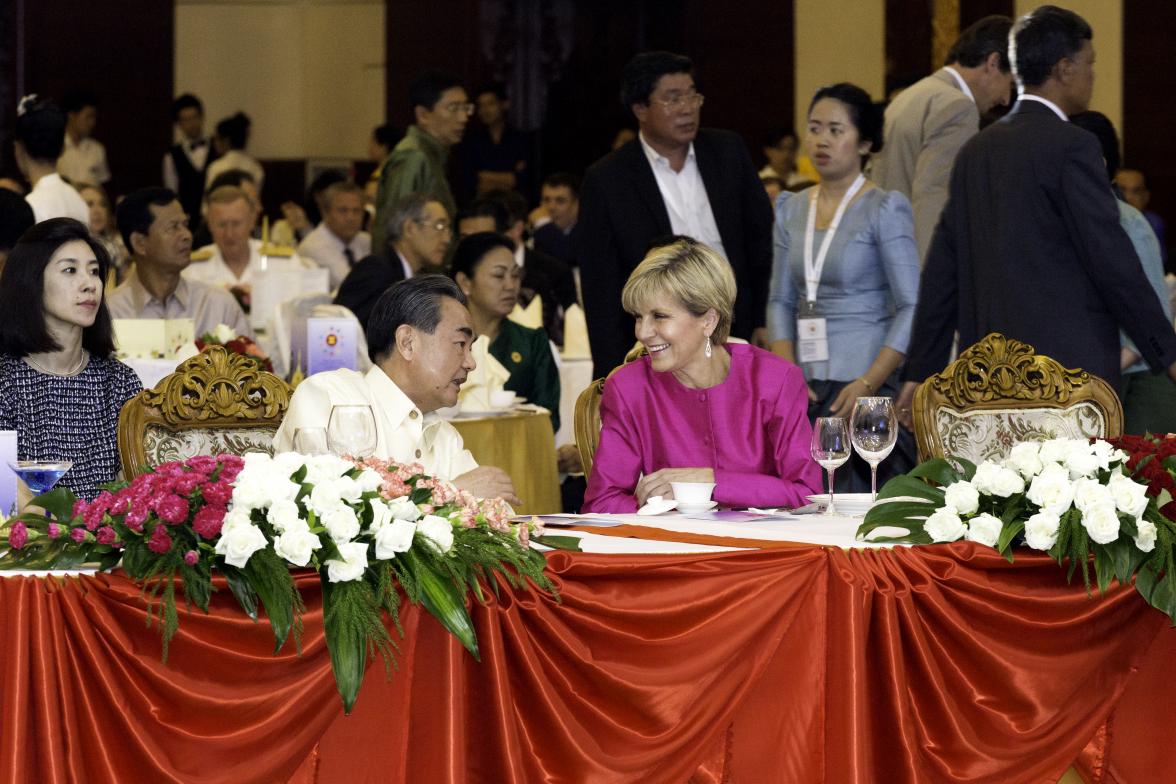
left=870, top=15, right=1013, bottom=264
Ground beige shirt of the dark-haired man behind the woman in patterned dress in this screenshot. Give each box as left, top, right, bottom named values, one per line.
left=106, top=268, right=253, bottom=337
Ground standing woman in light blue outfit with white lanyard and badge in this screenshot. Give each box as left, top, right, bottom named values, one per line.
left=768, top=82, right=920, bottom=491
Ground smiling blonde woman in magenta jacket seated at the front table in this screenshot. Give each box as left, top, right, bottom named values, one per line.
left=583, top=239, right=821, bottom=512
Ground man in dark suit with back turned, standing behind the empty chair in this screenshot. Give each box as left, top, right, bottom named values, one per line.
left=898, top=6, right=1176, bottom=416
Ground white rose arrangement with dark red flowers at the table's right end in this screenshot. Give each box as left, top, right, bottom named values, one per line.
left=857, top=436, right=1176, bottom=622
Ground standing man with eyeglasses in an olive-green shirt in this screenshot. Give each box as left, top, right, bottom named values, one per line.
left=372, top=71, right=474, bottom=248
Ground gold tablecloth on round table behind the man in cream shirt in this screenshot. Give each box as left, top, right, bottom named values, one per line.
left=452, top=409, right=561, bottom=515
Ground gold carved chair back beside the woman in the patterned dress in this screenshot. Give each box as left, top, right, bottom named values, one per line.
left=119, top=346, right=290, bottom=480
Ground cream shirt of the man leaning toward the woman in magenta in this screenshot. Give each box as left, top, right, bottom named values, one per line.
left=274, top=367, right=477, bottom=480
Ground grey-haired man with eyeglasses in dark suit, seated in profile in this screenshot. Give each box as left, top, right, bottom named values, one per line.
left=335, top=193, right=453, bottom=329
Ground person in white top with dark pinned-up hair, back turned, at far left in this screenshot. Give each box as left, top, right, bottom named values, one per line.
left=13, top=95, right=89, bottom=226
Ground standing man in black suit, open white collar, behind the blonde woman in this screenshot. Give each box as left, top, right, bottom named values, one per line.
left=576, top=52, right=771, bottom=375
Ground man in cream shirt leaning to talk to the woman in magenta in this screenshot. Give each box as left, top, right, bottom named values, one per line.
left=274, top=275, right=520, bottom=504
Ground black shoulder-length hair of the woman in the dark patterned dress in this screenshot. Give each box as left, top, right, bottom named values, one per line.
left=0, top=217, right=114, bottom=357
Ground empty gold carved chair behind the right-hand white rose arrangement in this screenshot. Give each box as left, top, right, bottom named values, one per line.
left=914, top=333, right=1123, bottom=463
